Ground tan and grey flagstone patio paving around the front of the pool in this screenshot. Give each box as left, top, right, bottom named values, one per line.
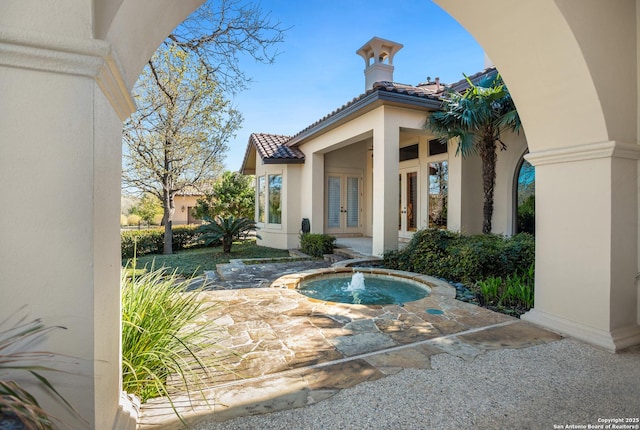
left=141, top=261, right=560, bottom=429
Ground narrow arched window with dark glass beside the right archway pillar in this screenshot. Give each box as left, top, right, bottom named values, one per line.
left=515, top=158, right=536, bottom=234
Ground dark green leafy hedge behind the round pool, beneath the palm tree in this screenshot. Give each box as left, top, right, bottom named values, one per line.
left=384, top=229, right=535, bottom=284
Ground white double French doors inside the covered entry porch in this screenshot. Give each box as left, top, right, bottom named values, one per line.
left=326, top=173, right=362, bottom=234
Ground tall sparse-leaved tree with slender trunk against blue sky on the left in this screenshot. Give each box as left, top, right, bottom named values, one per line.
left=123, top=0, right=284, bottom=254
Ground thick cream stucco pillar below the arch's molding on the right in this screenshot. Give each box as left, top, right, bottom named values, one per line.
left=523, top=141, right=640, bottom=351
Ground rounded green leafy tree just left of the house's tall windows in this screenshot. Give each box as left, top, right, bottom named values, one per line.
left=195, top=171, right=256, bottom=219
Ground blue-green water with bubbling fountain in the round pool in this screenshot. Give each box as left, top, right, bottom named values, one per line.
left=298, top=273, right=429, bottom=305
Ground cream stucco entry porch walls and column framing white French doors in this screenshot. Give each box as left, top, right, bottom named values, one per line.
left=299, top=106, right=436, bottom=254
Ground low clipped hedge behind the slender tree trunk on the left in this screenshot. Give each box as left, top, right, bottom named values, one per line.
left=120, top=226, right=201, bottom=258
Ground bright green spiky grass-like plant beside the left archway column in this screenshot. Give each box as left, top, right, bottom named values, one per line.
left=122, top=267, right=228, bottom=416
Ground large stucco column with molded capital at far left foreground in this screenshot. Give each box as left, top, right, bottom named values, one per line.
left=0, top=26, right=135, bottom=429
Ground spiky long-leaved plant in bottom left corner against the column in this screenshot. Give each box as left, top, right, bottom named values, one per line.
left=0, top=314, right=75, bottom=430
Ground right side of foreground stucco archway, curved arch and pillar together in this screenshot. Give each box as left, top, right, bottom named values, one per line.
left=436, top=0, right=640, bottom=351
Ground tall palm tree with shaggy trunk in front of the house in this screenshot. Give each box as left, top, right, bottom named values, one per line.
left=425, top=73, right=520, bottom=233
